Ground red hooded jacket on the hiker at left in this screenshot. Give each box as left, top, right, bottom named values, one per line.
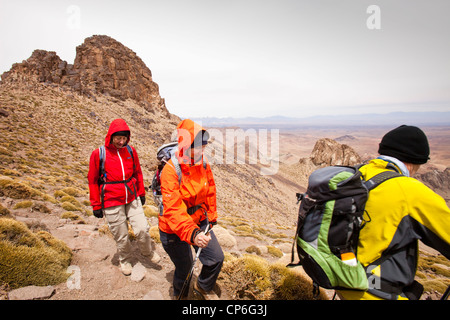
left=88, top=119, right=145, bottom=210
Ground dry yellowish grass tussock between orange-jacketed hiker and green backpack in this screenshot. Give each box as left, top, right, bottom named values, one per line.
left=218, top=254, right=328, bottom=300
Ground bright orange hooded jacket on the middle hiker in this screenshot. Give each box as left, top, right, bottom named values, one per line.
left=159, top=119, right=217, bottom=244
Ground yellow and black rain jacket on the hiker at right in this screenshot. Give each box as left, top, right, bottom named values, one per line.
left=339, top=159, right=450, bottom=300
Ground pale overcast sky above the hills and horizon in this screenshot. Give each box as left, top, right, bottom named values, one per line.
left=0, top=0, right=450, bottom=117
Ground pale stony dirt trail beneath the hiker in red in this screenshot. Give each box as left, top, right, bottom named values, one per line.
left=12, top=213, right=178, bottom=300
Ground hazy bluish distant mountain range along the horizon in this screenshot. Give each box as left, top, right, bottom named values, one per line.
left=193, top=112, right=450, bottom=130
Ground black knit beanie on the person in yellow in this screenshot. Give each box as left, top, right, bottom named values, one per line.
left=378, top=125, right=430, bottom=164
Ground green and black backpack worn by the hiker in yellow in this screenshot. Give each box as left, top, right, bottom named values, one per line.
left=288, top=165, right=401, bottom=293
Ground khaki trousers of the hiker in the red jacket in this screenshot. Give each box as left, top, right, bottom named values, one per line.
left=104, top=198, right=152, bottom=263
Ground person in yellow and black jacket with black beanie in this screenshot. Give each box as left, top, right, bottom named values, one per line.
left=338, top=125, right=450, bottom=300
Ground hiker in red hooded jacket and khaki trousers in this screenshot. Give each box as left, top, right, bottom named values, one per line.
left=88, top=119, right=159, bottom=275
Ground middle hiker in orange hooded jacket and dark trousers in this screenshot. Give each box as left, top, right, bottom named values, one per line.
left=159, top=119, right=224, bottom=298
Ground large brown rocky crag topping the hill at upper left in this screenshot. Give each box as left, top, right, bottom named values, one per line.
left=2, top=35, right=170, bottom=116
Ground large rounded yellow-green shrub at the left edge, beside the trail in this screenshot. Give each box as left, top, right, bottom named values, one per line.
left=0, top=218, right=72, bottom=289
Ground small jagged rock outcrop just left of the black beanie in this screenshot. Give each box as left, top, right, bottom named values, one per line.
left=310, top=138, right=361, bottom=166
